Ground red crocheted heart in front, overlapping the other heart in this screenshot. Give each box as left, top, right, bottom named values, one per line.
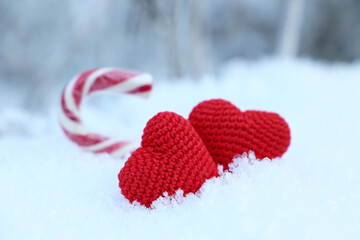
left=118, top=112, right=218, bottom=207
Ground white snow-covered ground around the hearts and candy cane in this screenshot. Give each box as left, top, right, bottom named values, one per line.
left=0, top=60, right=360, bottom=239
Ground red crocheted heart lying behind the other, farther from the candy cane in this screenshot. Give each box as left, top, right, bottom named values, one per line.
left=189, top=99, right=290, bottom=169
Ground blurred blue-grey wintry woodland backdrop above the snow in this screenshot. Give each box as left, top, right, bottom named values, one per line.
left=0, top=0, right=360, bottom=111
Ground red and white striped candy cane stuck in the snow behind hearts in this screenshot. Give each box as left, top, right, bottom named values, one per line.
left=59, top=68, right=152, bottom=157
